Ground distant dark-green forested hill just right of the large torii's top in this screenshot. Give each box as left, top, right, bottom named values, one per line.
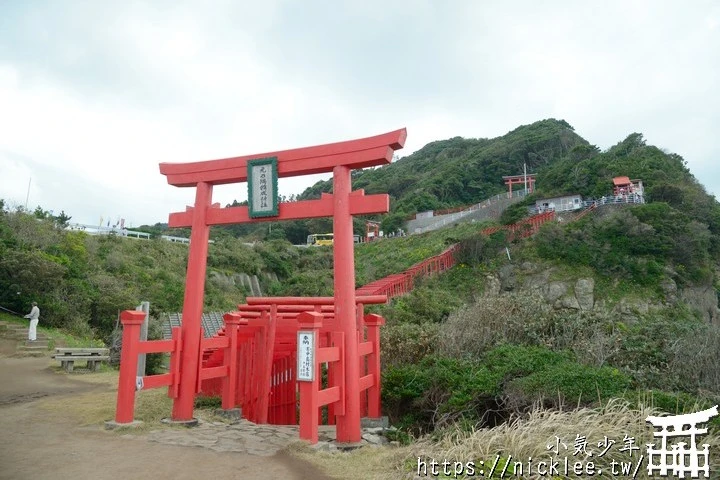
left=301, top=119, right=588, bottom=223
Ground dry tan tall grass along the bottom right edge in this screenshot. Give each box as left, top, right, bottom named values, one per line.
left=403, top=400, right=720, bottom=478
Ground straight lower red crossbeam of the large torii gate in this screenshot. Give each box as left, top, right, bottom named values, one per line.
left=168, top=194, right=390, bottom=228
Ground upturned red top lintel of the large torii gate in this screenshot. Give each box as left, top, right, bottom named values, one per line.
left=160, top=128, right=407, bottom=187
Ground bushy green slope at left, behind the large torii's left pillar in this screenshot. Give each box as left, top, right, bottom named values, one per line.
left=0, top=210, right=332, bottom=338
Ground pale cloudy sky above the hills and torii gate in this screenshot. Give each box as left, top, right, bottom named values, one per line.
left=0, top=0, right=720, bottom=226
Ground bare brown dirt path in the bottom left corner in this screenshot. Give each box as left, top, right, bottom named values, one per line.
left=0, top=346, right=330, bottom=480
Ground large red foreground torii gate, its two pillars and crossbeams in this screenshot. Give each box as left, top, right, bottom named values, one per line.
left=160, top=128, right=407, bottom=442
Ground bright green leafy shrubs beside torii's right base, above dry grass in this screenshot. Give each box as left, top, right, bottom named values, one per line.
left=382, top=345, right=631, bottom=431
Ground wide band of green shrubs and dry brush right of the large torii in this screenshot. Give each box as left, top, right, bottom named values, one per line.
left=383, top=290, right=720, bottom=430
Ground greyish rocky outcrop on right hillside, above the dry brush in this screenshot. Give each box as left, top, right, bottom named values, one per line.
left=485, top=262, right=720, bottom=325
